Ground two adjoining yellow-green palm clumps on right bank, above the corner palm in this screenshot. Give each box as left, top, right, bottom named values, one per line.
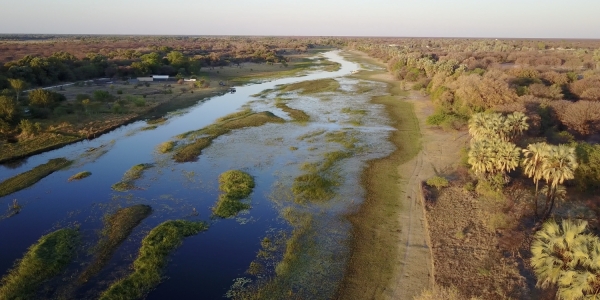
left=468, top=112, right=577, bottom=219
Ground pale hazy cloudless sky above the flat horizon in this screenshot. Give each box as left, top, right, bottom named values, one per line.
left=0, top=0, right=600, bottom=38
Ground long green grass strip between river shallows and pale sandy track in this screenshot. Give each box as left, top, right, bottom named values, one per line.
left=336, top=71, right=421, bottom=299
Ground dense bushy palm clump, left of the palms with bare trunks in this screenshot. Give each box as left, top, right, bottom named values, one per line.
left=468, top=112, right=529, bottom=178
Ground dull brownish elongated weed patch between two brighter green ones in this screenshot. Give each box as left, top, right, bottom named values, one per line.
left=77, top=204, right=152, bottom=283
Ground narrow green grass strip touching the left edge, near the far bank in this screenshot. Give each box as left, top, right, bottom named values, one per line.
left=0, top=158, right=72, bottom=197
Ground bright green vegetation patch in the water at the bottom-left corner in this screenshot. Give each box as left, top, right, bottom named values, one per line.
left=0, top=228, right=79, bottom=299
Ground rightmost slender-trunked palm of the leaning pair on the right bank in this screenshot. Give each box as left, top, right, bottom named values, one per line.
left=542, top=145, right=577, bottom=218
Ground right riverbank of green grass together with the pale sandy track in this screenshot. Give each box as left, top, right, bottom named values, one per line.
left=337, top=52, right=465, bottom=299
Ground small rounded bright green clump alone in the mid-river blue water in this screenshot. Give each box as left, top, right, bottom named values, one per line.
left=213, top=170, right=254, bottom=218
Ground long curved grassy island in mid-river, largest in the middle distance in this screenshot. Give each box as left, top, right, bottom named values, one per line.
left=173, top=110, right=285, bottom=162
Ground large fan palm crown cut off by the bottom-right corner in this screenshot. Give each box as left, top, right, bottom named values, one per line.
left=531, top=220, right=600, bottom=300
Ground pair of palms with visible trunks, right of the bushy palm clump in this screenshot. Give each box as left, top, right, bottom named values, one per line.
left=522, top=143, right=577, bottom=219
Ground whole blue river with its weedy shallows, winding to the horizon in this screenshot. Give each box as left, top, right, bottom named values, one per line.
left=0, top=51, right=393, bottom=299
